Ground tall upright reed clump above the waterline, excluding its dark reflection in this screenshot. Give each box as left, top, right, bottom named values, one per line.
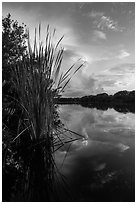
left=12, top=25, right=83, bottom=143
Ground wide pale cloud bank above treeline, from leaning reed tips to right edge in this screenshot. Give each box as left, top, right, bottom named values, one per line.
left=64, top=63, right=135, bottom=97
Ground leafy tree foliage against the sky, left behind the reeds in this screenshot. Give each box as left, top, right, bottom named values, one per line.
left=2, top=14, right=27, bottom=81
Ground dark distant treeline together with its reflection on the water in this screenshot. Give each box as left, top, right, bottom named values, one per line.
left=57, top=90, right=135, bottom=113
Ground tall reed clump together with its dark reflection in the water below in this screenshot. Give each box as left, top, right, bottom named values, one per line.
left=3, top=25, right=83, bottom=201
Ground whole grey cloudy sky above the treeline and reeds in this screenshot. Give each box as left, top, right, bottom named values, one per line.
left=2, top=2, right=135, bottom=97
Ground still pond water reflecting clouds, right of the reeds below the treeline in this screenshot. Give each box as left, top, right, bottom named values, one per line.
left=56, top=105, right=135, bottom=202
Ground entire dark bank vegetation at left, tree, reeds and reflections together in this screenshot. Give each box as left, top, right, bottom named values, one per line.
left=2, top=14, right=83, bottom=202
